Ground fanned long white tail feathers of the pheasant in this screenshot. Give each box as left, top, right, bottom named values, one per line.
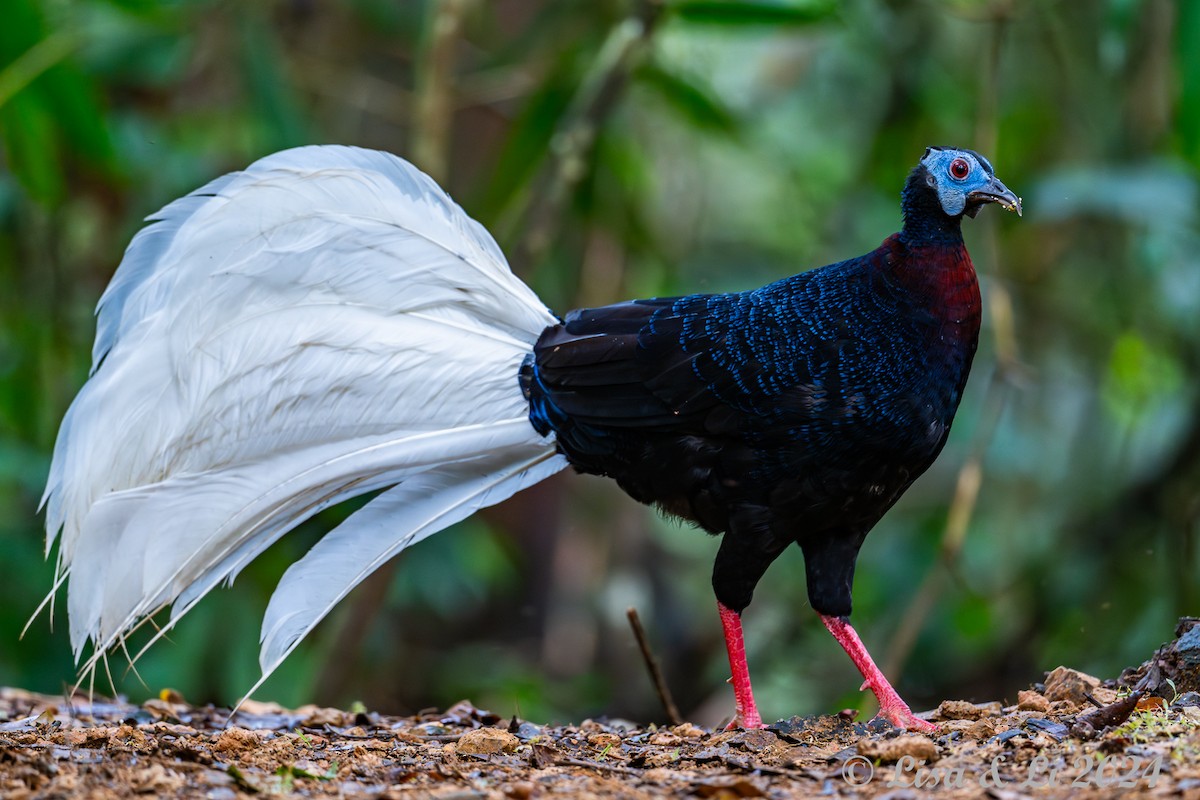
left=43, top=146, right=566, bottom=678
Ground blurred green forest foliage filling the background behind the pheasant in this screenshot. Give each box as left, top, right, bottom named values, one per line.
left=0, top=0, right=1200, bottom=724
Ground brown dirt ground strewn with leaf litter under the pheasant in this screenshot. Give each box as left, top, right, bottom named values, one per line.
left=7, top=619, right=1200, bottom=800
